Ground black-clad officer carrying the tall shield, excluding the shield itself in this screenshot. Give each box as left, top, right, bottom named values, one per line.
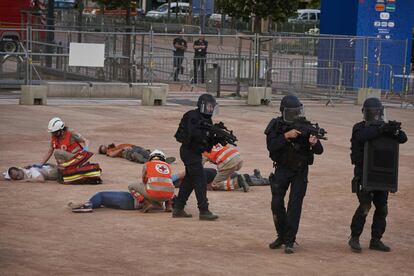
left=348, top=98, right=407, bottom=252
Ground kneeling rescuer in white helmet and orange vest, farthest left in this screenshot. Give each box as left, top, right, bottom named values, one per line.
left=40, top=117, right=89, bottom=166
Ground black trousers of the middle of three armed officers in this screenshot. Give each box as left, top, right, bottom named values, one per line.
left=270, top=166, right=308, bottom=244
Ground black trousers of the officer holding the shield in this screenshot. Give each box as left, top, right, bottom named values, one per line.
left=351, top=191, right=388, bottom=239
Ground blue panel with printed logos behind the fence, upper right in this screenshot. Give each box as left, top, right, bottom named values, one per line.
left=318, top=0, right=414, bottom=92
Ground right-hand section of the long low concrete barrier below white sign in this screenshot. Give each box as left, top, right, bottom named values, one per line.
left=90, top=82, right=131, bottom=98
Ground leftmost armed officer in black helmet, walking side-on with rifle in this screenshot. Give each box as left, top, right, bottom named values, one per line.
left=172, top=94, right=218, bottom=220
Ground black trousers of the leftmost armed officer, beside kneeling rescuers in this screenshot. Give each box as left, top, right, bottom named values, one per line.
left=174, top=147, right=208, bottom=211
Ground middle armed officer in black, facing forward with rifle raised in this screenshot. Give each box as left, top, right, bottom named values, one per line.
left=265, top=95, right=323, bottom=254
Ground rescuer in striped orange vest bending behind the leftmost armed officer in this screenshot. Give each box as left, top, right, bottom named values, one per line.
left=203, top=143, right=249, bottom=192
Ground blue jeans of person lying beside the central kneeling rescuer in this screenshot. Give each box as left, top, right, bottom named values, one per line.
left=89, top=191, right=134, bottom=210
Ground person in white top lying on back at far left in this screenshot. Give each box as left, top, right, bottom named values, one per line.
left=3, top=164, right=59, bottom=182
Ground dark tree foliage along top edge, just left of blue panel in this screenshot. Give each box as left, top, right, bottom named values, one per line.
left=216, top=0, right=298, bottom=21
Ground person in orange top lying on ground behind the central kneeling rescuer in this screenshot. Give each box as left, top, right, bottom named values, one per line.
left=98, top=143, right=175, bottom=164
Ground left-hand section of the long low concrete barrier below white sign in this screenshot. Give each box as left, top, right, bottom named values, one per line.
left=46, top=82, right=90, bottom=98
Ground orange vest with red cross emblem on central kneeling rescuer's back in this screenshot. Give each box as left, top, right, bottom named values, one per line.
left=145, top=160, right=174, bottom=201
